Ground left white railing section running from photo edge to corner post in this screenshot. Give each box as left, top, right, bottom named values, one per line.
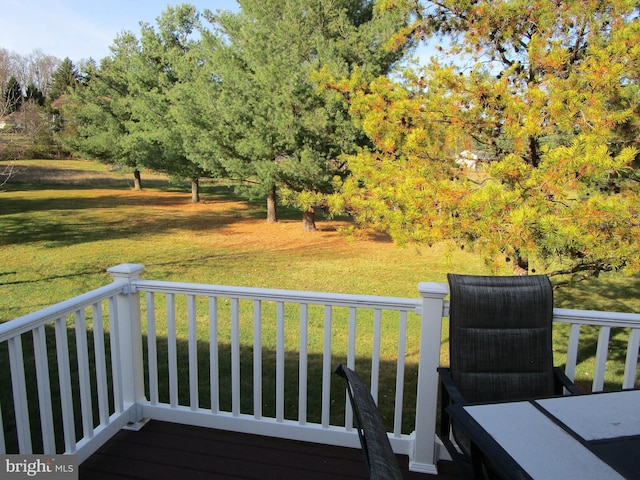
left=0, top=283, right=137, bottom=459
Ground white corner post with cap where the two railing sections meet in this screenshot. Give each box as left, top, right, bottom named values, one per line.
left=107, top=263, right=144, bottom=423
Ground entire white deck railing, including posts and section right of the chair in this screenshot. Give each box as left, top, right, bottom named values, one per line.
left=0, top=264, right=640, bottom=473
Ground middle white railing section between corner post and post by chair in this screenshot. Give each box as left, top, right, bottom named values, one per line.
left=131, top=270, right=447, bottom=473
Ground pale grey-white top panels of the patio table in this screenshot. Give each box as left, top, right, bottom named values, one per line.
left=464, top=391, right=640, bottom=480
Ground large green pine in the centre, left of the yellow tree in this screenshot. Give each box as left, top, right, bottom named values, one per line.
left=202, top=0, right=408, bottom=229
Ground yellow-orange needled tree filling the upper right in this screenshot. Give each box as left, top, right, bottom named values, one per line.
left=330, top=0, right=640, bottom=283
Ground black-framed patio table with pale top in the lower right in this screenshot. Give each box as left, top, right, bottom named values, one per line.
left=448, top=390, right=640, bottom=480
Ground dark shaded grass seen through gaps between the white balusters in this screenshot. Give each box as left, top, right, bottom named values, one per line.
left=0, top=325, right=417, bottom=454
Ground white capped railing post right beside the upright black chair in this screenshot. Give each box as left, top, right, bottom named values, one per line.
left=409, top=282, right=449, bottom=474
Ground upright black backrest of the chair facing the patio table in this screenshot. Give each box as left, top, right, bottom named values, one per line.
left=448, top=274, right=554, bottom=402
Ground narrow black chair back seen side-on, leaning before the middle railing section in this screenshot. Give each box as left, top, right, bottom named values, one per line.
left=336, top=365, right=402, bottom=480
